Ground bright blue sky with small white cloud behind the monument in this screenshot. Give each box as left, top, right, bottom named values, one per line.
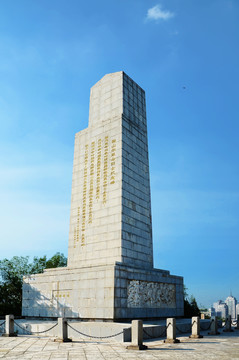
left=0, top=0, right=239, bottom=306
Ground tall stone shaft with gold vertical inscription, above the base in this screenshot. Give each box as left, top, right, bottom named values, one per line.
left=68, top=72, right=153, bottom=268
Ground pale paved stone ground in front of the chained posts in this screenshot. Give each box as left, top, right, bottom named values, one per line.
left=0, top=330, right=239, bottom=360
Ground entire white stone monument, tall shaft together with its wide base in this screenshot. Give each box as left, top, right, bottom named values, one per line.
left=22, top=71, right=183, bottom=320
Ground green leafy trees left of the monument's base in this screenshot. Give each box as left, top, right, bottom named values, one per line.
left=0, top=252, right=67, bottom=315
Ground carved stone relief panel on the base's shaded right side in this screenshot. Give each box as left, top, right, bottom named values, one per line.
left=127, top=280, right=176, bottom=308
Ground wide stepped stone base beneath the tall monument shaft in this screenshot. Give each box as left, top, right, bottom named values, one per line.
left=22, top=263, right=184, bottom=321
